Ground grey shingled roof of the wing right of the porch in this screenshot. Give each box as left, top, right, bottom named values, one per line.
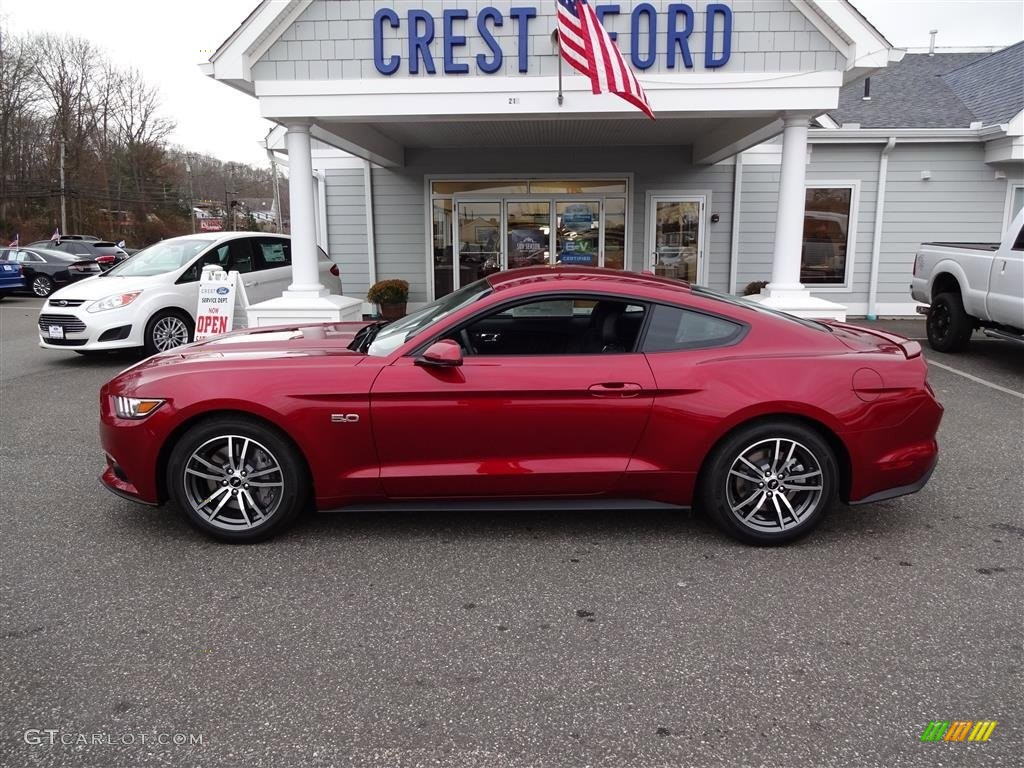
left=828, top=42, right=1024, bottom=128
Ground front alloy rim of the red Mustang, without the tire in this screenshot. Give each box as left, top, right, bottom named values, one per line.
left=182, top=434, right=285, bottom=531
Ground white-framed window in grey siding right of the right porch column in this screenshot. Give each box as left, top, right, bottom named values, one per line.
left=800, top=184, right=856, bottom=286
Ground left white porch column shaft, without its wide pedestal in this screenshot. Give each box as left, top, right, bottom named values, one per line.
left=285, top=123, right=328, bottom=298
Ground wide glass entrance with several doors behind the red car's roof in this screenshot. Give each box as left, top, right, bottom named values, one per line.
left=429, top=178, right=629, bottom=298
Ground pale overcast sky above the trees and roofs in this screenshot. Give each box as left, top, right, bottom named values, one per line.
left=0, top=0, right=1024, bottom=165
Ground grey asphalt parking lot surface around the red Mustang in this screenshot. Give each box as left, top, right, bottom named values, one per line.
left=0, top=298, right=1024, bottom=768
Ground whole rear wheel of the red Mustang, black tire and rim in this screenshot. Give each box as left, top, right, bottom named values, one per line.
left=698, top=420, right=840, bottom=546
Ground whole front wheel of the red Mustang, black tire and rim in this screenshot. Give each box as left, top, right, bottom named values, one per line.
left=167, top=417, right=310, bottom=543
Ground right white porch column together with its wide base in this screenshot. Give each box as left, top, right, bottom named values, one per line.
left=751, top=115, right=857, bottom=321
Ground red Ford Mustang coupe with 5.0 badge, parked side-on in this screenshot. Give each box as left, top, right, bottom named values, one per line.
left=100, top=267, right=942, bottom=544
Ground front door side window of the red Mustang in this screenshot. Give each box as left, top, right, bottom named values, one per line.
left=450, top=296, right=646, bottom=355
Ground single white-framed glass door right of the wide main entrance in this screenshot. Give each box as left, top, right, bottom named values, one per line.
left=648, top=196, right=705, bottom=283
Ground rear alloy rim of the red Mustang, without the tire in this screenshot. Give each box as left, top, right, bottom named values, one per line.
left=725, top=437, right=824, bottom=534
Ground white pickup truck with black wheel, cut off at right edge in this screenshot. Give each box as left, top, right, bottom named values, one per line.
left=910, top=211, right=1024, bottom=352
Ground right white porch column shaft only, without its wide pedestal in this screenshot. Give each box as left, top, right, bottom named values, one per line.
left=768, top=117, right=808, bottom=292
